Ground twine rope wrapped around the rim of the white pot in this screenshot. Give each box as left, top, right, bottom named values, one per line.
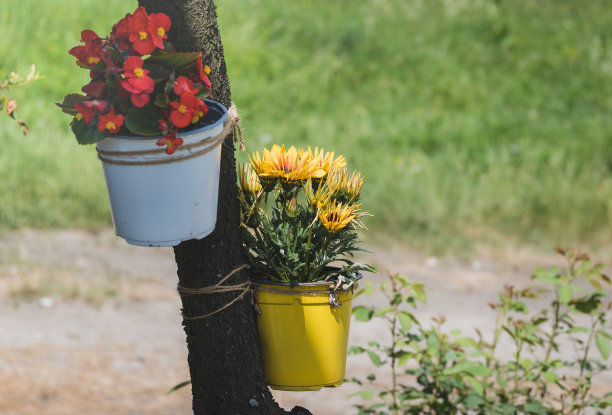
left=96, top=103, right=245, bottom=166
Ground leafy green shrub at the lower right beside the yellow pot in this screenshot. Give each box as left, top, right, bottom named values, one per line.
left=349, top=248, right=612, bottom=415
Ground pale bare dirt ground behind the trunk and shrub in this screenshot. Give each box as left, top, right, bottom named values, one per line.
left=0, top=230, right=612, bottom=415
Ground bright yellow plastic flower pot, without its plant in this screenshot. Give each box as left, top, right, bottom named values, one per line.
left=255, top=282, right=353, bottom=391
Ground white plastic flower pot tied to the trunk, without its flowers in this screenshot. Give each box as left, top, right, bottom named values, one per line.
left=97, top=100, right=227, bottom=246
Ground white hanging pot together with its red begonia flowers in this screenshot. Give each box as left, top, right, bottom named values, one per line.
left=58, top=7, right=239, bottom=246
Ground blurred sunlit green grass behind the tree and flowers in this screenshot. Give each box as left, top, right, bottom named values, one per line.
left=0, top=0, right=612, bottom=254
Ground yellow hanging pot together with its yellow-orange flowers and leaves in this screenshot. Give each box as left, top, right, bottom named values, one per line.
left=238, top=145, right=376, bottom=390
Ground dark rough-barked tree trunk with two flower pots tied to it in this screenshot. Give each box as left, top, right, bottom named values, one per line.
left=138, top=0, right=310, bottom=415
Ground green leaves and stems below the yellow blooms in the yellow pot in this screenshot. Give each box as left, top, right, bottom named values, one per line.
left=239, top=162, right=376, bottom=289
